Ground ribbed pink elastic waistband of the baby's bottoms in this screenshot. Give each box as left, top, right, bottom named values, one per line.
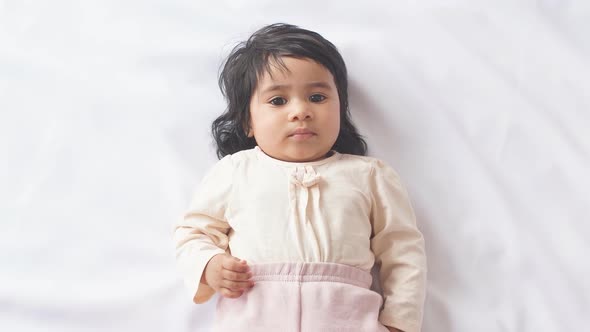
left=250, top=263, right=373, bottom=288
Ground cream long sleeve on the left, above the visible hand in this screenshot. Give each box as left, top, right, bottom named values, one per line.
left=174, top=156, right=234, bottom=303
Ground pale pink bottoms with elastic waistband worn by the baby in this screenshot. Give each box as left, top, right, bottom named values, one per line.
left=213, top=263, right=388, bottom=332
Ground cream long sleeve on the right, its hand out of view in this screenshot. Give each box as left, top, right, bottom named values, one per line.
left=371, top=160, right=426, bottom=332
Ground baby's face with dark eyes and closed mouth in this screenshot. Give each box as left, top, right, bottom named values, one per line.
left=248, top=57, right=340, bottom=162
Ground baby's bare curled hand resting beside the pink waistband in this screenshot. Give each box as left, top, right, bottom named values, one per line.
left=201, top=254, right=254, bottom=298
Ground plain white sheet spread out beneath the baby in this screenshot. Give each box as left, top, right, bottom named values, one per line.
left=0, top=0, right=590, bottom=332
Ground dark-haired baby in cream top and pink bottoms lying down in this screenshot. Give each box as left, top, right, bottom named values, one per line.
left=174, top=24, right=426, bottom=332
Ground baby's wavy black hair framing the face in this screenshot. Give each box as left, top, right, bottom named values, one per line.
left=211, top=23, right=367, bottom=159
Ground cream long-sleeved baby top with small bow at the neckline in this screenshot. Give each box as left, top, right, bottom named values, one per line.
left=174, top=147, right=426, bottom=332
